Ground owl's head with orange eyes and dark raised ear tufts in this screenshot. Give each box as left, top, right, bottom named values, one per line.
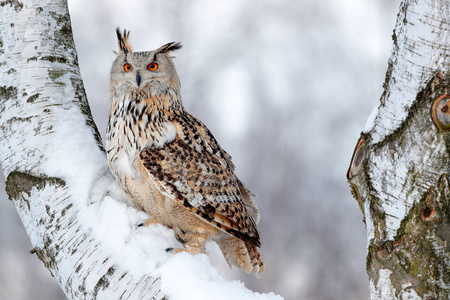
left=111, top=28, right=182, bottom=93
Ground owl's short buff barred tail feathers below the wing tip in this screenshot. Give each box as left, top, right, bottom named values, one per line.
left=219, top=236, right=264, bottom=278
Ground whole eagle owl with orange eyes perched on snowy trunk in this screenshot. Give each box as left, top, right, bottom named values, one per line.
left=106, top=28, right=264, bottom=277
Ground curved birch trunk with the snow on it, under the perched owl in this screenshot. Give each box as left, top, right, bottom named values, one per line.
left=0, top=0, right=282, bottom=299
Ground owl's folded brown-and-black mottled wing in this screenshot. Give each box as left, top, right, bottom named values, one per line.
left=139, top=116, right=261, bottom=246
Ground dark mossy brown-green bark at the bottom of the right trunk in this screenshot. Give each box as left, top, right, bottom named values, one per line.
left=367, top=174, right=450, bottom=299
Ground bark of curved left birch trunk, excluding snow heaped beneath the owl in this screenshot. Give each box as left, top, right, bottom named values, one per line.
left=0, top=0, right=164, bottom=299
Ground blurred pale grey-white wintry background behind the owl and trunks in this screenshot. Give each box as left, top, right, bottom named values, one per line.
left=0, top=0, right=400, bottom=300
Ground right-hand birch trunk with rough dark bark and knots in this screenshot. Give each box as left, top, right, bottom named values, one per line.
left=347, top=0, right=450, bottom=299
